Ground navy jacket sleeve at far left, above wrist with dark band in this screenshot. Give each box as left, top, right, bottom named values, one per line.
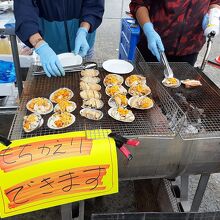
left=14, top=0, right=40, bottom=47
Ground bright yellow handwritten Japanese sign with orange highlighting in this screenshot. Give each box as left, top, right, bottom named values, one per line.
left=0, top=130, right=118, bottom=218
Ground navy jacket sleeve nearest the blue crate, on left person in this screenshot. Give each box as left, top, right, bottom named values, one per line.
left=80, top=0, right=105, bottom=32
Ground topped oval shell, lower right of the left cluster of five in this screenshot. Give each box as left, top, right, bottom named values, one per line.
left=47, top=112, right=76, bottom=129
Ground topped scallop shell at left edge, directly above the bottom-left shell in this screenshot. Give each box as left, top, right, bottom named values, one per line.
left=26, top=97, right=53, bottom=115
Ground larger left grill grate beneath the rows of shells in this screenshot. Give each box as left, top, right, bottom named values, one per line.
left=10, top=62, right=184, bottom=139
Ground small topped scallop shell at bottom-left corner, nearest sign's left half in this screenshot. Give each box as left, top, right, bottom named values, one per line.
left=23, top=113, right=44, bottom=133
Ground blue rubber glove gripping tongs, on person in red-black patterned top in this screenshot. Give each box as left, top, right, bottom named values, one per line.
left=143, top=22, right=164, bottom=61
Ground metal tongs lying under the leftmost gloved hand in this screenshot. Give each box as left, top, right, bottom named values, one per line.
left=33, top=62, right=98, bottom=76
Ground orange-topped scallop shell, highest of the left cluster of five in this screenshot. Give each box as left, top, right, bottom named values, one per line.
left=50, top=87, right=74, bottom=103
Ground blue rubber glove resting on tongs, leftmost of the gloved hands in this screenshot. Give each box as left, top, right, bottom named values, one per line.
left=35, top=42, right=65, bottom=77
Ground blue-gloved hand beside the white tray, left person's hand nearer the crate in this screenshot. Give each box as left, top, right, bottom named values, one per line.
left=74, top=27, right=89, bottom=57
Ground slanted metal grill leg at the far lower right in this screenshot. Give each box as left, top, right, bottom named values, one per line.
left=190, top=174, right=210, bottom=212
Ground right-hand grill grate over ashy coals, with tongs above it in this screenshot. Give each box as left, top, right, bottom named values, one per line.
left=140, top=63, right=220, bottom=139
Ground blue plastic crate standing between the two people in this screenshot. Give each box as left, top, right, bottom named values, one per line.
left=119, top=18, right=140, bottom=62
